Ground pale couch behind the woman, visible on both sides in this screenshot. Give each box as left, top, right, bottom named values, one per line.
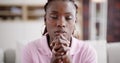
left=0, top=41, right=120, bottom=63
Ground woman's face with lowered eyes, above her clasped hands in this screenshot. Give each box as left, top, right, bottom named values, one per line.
left=45, top=1, right=76, bottom=41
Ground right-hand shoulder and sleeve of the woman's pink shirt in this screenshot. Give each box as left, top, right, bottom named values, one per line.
left=71, top=39, right=97, bottom=63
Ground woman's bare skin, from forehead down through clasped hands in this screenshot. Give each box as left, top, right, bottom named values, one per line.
left=45, top=0, right=76, bottom=63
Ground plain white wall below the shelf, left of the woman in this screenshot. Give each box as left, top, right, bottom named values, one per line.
left=0, top=21, right=44, bottom=50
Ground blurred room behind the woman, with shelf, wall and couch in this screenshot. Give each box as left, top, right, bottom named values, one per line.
left=0, top=0, right=120, bottom=63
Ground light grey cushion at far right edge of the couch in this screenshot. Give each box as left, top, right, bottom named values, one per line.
left=107, top=42, right=120, bottom=63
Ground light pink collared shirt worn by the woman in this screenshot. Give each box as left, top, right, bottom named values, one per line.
left=22, top=36, right=97, bottom=63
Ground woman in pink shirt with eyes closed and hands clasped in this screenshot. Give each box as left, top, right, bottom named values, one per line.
left=22, top=0, right=96, bottom=63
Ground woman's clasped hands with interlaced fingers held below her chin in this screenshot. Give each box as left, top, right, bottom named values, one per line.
left=50, top=35, right=72, bottom=63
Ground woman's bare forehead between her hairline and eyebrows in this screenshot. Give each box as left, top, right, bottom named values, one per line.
left=47, top=1, right=76, bottom=13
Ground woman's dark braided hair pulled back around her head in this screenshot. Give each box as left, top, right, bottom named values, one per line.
left=43, top=0, right=78, bottom=35
